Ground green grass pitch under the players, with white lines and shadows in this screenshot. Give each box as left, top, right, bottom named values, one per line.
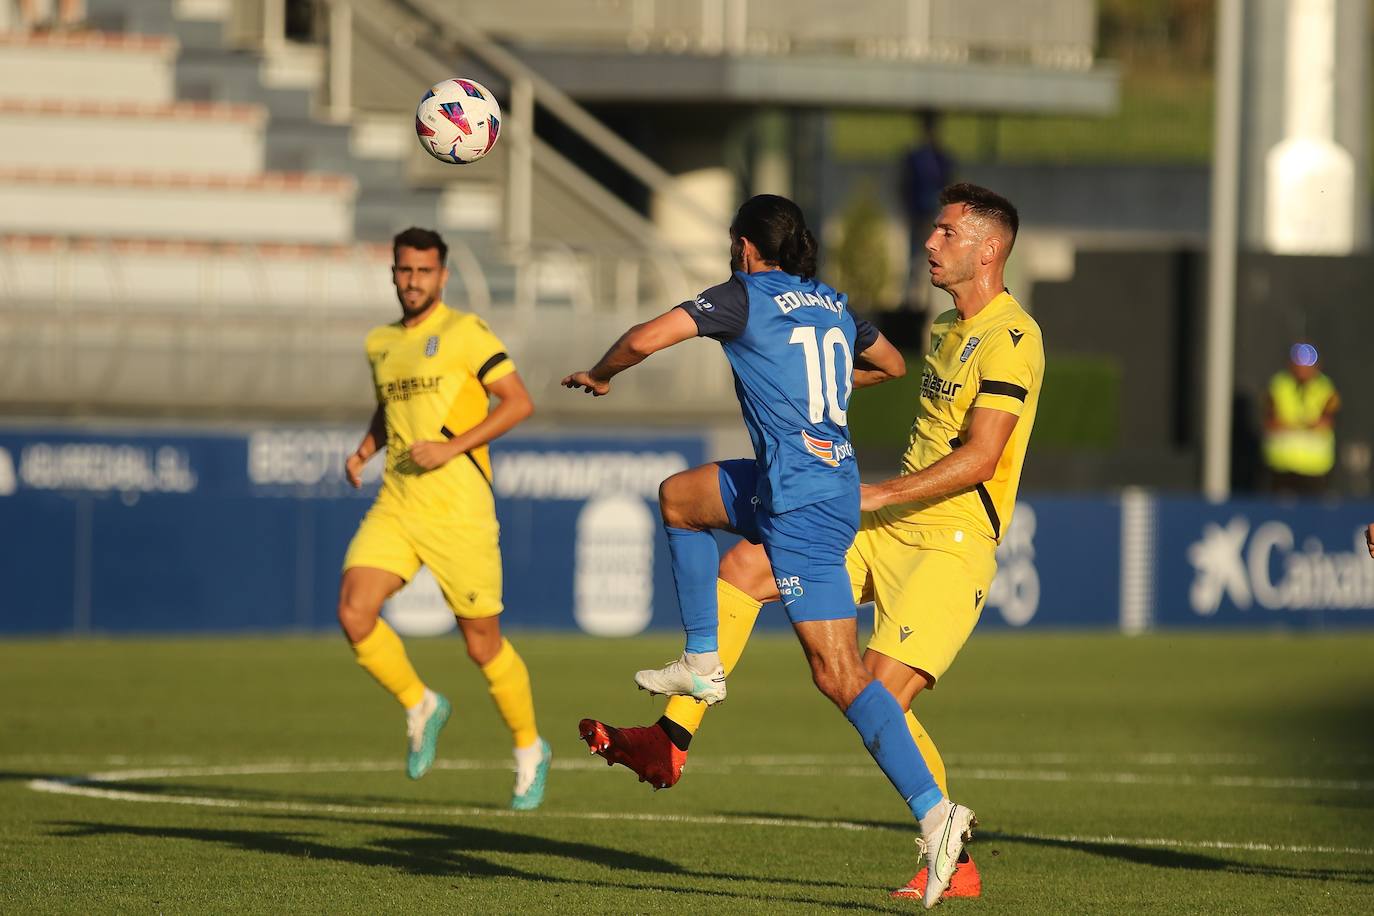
left=0, top=633, right=1374, bottom=915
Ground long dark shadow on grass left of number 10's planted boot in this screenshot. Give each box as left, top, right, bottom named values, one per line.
left=52, top=816, right=888, bottom=912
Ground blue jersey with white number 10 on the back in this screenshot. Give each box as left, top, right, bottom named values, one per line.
left=679, top=271, right=878, bottom=512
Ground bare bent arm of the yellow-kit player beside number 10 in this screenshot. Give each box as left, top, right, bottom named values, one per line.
left=859, top=407, right=1017, bottom=511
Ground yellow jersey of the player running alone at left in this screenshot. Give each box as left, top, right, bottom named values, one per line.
left=367, top=302, right=515, bottom=516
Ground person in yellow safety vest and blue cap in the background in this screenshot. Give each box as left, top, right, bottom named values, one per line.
left=1264, top=342, right=1341, bottom=496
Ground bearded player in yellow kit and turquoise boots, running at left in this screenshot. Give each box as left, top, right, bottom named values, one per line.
left=339, top=228, right=551, bottom=810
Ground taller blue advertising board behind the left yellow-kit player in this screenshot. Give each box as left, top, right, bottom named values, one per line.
left=0, top=428, right=705, bottom=636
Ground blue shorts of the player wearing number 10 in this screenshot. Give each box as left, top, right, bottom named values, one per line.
left=717, top=459, right=859, bottom=623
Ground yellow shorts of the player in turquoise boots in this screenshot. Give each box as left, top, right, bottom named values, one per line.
left=344, top=503, right=502, bottom=618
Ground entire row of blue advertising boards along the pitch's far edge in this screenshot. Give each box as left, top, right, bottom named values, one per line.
left=0, top=427, right=1374, bottom=636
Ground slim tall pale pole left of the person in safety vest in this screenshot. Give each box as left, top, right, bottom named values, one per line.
left=1202, top=0, right=1242, bottom=501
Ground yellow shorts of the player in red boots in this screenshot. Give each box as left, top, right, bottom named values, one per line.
left=845, top=512, right=998, bottom=685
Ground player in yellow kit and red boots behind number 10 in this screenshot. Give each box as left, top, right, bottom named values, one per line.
left=581, top=184, right=1044, bottom=897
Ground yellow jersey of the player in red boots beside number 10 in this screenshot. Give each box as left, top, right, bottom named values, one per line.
left=878, top=291, right=1044, bottom=541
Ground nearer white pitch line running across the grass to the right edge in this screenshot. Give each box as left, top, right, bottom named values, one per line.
left=29, top=761, right=1374, bottom=856
